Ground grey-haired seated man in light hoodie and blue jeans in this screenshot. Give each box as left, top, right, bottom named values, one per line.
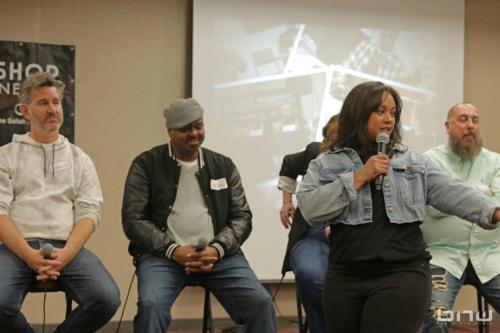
left=0, top=73, right=120, bottom=333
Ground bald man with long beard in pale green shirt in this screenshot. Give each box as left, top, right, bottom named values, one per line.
left=421, top=103, right=500, bottom=333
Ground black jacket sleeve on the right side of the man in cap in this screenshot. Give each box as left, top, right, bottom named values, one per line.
left=212, top=162, right=252, bottom=257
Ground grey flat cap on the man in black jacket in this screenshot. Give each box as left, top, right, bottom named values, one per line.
left=163, top=98, right=203, bottom=129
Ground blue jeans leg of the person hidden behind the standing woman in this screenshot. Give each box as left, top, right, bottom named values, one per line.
left=290, top=225, right=330, bottom=333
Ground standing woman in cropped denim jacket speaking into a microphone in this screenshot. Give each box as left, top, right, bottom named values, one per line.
left=297, top=82, right=500, bottom=333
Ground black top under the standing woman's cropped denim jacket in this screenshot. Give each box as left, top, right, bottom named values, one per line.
left=329, top=182, right=431, bottom=270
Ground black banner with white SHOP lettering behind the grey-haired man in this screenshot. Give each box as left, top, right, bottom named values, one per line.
left=0, top=41, right=75, bottom=146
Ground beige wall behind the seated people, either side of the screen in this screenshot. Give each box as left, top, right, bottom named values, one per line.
left=0, top=0, right=500, bottom=322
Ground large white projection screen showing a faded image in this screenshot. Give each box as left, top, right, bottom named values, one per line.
left=193, top=0, right=463, bottom=277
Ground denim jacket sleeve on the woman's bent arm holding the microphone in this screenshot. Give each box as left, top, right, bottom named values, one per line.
left=297, top=159, right=358, bottom=224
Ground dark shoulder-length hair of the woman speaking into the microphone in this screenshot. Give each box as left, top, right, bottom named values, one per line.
left=333, top=81, right=403, bottom=160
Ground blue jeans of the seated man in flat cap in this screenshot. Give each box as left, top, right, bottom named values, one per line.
left=134, top=254, right=276, bottom=333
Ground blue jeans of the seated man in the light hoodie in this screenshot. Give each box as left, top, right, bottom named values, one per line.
left=0, top=240, right=120, bottom=333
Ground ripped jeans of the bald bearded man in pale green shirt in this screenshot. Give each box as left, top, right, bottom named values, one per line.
left=422, top=263, right=500, bottom=333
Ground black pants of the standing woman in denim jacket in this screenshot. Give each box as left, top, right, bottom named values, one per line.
left=323, top=262, right=431, bottom=333
